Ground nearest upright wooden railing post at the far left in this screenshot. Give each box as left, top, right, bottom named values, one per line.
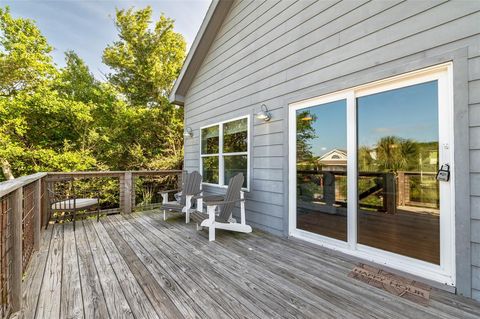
left=10, top=187, right=23, bottom=312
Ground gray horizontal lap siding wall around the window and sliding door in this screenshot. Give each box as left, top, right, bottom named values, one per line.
left=185, top=0, right=480, bottom=300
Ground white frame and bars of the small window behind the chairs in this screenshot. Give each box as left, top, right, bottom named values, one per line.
left=199, top=115, right=250, bottom=192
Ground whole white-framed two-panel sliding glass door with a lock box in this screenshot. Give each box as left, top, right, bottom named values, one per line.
left=289, top=65, right=455, bottom=284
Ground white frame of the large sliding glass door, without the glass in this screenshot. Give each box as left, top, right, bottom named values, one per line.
left=289, top=62, right=456, bottom=286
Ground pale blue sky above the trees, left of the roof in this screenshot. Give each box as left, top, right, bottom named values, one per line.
left=0, top=0, right=211, bottom=80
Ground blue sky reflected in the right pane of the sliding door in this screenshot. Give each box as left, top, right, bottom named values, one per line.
left=357, top=81, right=438, bottom=147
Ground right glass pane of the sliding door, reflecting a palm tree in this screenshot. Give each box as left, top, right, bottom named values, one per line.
left=356, top=80, right=440, bottom=264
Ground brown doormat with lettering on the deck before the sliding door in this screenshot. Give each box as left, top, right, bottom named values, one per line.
left=348, top=264, right=431, bottom=306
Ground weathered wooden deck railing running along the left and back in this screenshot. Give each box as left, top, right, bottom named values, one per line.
left=0, top=170, right=183, bottom=318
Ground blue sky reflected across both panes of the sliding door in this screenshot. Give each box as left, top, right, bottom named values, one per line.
left=298, top=81, right=439, bottom=156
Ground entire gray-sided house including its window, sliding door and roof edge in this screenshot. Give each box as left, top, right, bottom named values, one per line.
left=170, top=0, right=480, bottom=300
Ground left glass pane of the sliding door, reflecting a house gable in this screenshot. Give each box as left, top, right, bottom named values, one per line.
left=296, top=100, right=347, bottom=241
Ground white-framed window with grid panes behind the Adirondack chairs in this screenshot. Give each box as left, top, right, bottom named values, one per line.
left=200, top=117, right=250, bottom=189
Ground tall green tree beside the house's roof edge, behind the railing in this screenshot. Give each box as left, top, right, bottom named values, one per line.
left=103, top=7, right=186, bottom=168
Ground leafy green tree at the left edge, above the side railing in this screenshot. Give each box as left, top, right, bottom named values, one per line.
left=0, top=8, right=96, bottom=179
